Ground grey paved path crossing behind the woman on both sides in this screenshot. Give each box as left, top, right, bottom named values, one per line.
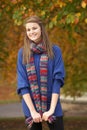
left=0, top=101, right=87, bottom=118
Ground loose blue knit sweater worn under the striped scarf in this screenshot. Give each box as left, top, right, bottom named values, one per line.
left=17, top=45, right=65, bottom=117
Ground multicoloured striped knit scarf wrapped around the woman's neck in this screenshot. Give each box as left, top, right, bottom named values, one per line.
left=26, top=43, right=54, bottom=127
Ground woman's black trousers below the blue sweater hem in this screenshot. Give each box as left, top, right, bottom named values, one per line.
left=30, top=116, right=64, bottom=130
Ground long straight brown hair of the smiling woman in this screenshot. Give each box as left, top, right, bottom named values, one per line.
left=23, top=16, right=53, bottom=64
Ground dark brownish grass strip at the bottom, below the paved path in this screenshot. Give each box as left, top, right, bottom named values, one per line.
left=0, top=117, right=87, bottom=130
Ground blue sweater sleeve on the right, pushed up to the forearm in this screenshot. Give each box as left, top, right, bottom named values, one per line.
left=52, top=46, right=65, bottom=94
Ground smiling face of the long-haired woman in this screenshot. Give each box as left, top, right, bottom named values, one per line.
left=26, top=23, right=41, bottom=43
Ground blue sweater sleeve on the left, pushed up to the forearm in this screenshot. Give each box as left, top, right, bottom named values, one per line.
left=17, top=48, right=29, bottom=94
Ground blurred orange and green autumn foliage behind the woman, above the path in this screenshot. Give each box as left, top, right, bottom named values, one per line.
left=0, top=0, right=87, bottom=130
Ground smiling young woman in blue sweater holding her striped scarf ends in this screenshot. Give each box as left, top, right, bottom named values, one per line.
left=17, top=16, right=65, bottom=130
